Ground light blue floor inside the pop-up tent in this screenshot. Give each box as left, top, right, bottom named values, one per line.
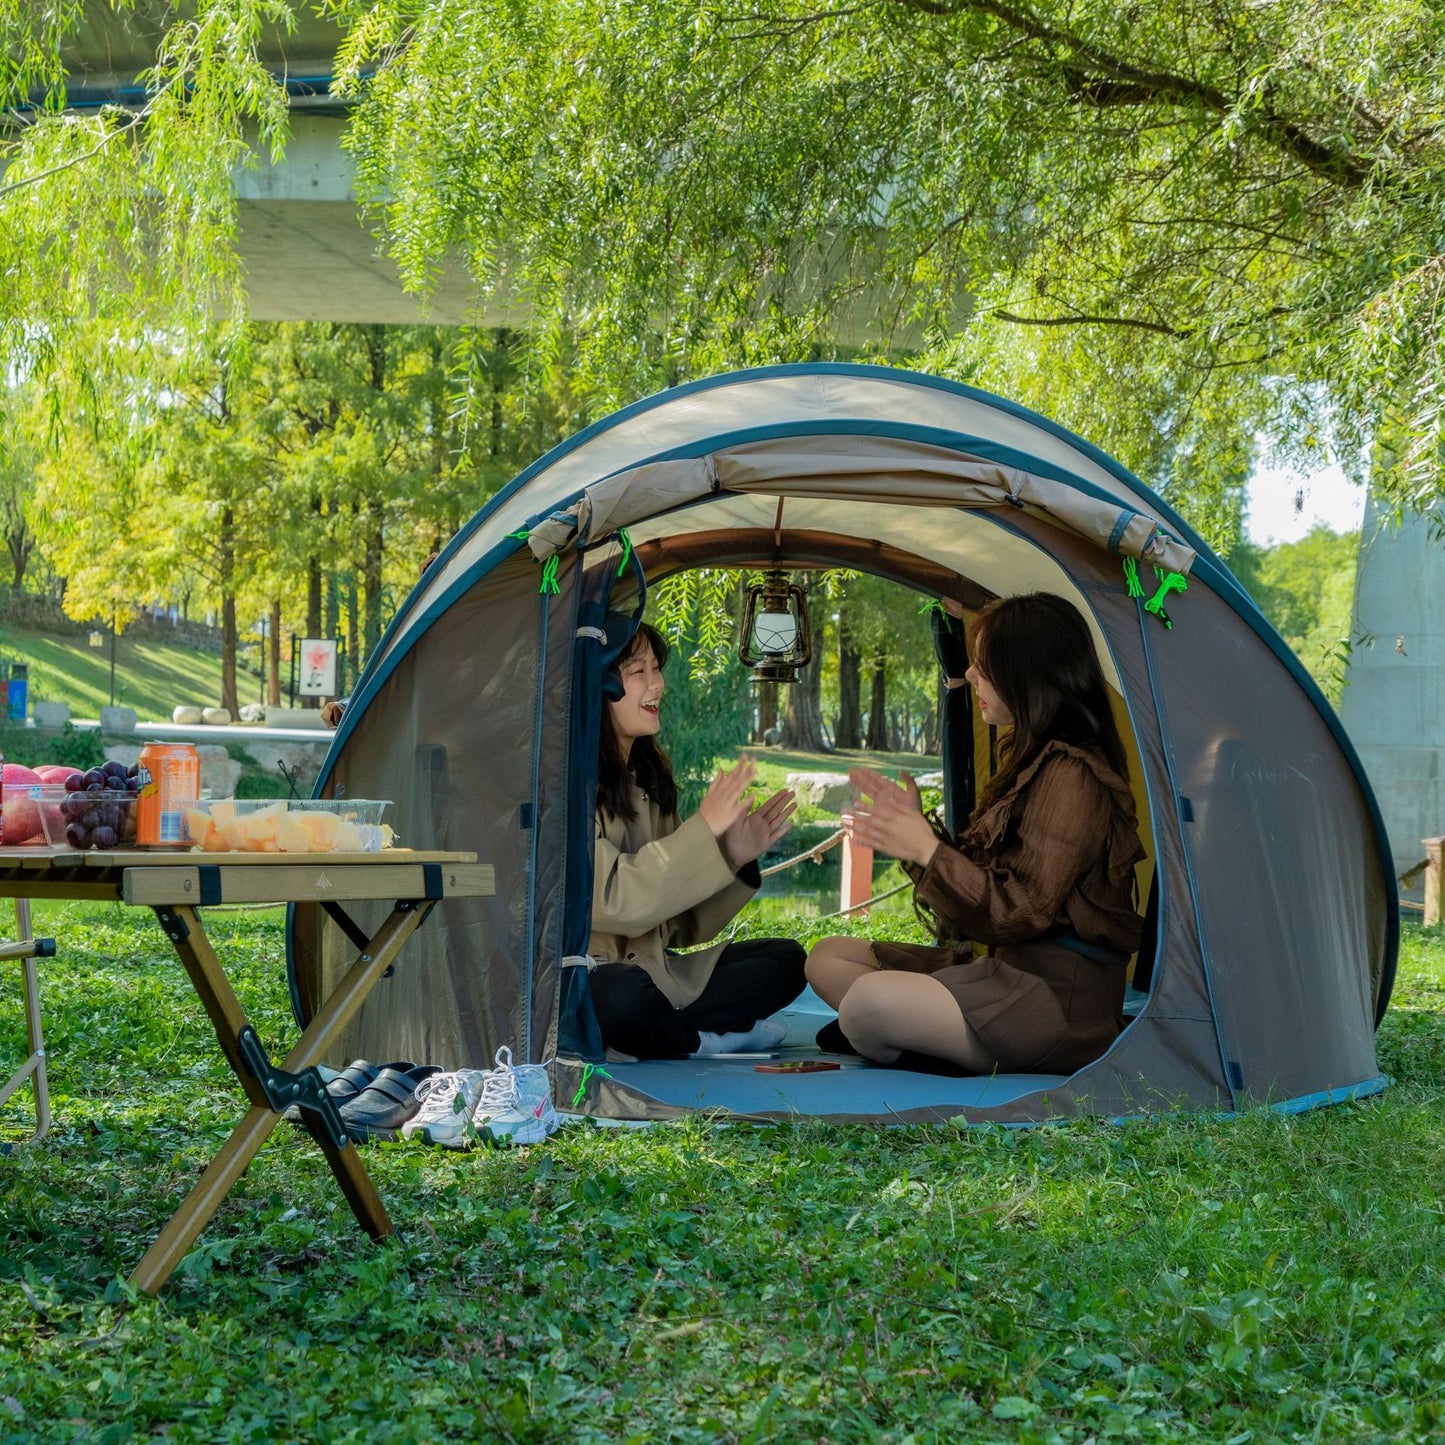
left=586, top=990, right=1069, bottom=1118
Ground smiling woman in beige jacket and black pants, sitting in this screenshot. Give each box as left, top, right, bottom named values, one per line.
left=587, top=623, right=805, bottom=1059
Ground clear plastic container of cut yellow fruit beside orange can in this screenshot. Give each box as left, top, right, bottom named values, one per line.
left=185, top=798, right=392, bottom=853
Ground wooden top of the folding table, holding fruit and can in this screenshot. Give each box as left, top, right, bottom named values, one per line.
left=0, top=847, right=496, bottom=907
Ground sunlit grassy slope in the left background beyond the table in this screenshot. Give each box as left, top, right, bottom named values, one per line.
left=0, top=623, right=262, bottom=723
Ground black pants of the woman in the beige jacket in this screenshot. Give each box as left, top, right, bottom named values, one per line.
left=588, top=938, right=808, bottom=1059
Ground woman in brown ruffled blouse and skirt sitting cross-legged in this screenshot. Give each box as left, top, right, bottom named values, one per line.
left=806, top=592, right=1144, bottom=1074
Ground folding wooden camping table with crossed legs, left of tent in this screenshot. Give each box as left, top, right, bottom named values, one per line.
left=0, top=848, right=493, bottom=1295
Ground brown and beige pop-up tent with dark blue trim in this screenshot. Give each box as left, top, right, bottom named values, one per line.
left=289, top=366, right=1397, bottom=1121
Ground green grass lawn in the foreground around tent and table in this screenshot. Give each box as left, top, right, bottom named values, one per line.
left=0, top=903, right=1445, bottom=1445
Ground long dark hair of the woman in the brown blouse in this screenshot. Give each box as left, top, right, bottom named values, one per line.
left=968, top=592, right=1129, bottom=812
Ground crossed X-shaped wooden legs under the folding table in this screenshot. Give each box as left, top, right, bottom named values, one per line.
left=130, top=903, right=432, bottom=1295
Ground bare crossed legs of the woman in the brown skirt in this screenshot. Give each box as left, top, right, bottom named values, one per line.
left=806, top=938, right=997, bottom=1074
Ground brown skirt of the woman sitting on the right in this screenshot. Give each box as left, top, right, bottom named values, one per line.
left=873, top=939, right=1127, bottom=1074
